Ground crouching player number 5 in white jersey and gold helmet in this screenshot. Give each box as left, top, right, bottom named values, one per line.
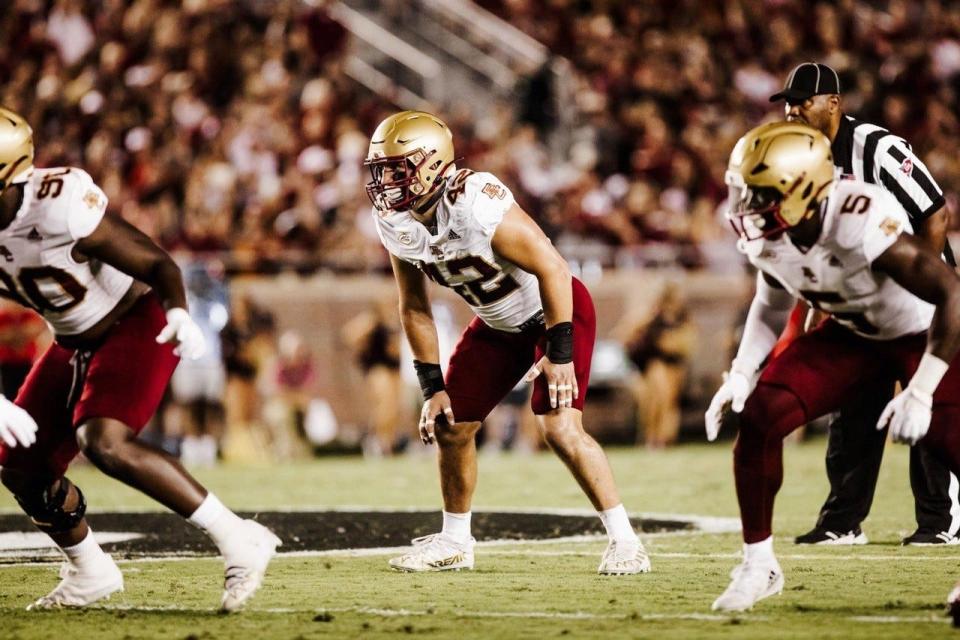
left=706, top=122, right=960, bottom=611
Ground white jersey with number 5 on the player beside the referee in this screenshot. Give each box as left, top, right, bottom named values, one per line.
left=738, top=179, right=934, bottom=340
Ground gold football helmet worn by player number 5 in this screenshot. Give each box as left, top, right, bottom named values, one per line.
left=726, top=122, right=834, bottom=241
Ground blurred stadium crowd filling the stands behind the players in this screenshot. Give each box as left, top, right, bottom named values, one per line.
left=0, top=0, right=960, bottom=272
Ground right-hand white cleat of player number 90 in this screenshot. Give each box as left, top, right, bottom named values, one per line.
left=220, top=520, right=282, bottom=611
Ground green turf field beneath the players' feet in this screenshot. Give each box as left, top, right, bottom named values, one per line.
left=0, top=441, right=960, bottom=640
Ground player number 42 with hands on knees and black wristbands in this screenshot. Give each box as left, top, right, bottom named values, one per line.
left=365, top=111, right=650, bottom=575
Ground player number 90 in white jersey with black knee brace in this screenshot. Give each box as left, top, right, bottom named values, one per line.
left=0, top=109, right=280, bottom=611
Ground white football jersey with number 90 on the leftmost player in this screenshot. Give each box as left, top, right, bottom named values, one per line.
left=0, top=167, right=133, bottom=335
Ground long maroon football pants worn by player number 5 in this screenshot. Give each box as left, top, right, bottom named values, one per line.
left=734, top=322, right=960, bottom=543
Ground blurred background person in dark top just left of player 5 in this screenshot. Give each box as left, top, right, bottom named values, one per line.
left=625, top=283, right=696, bottom=449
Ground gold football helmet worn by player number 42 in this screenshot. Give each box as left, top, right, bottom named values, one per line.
left=363, top=111, right=454, bottom=211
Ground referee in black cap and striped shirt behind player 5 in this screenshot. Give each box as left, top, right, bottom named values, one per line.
left=770, top=62, right=960, bottom=545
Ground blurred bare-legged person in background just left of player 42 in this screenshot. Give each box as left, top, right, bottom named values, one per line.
left=341, top=299, right=415, bottom=457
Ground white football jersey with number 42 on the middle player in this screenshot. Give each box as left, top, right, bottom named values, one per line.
left=373, top=169, right=543, bottom=332
